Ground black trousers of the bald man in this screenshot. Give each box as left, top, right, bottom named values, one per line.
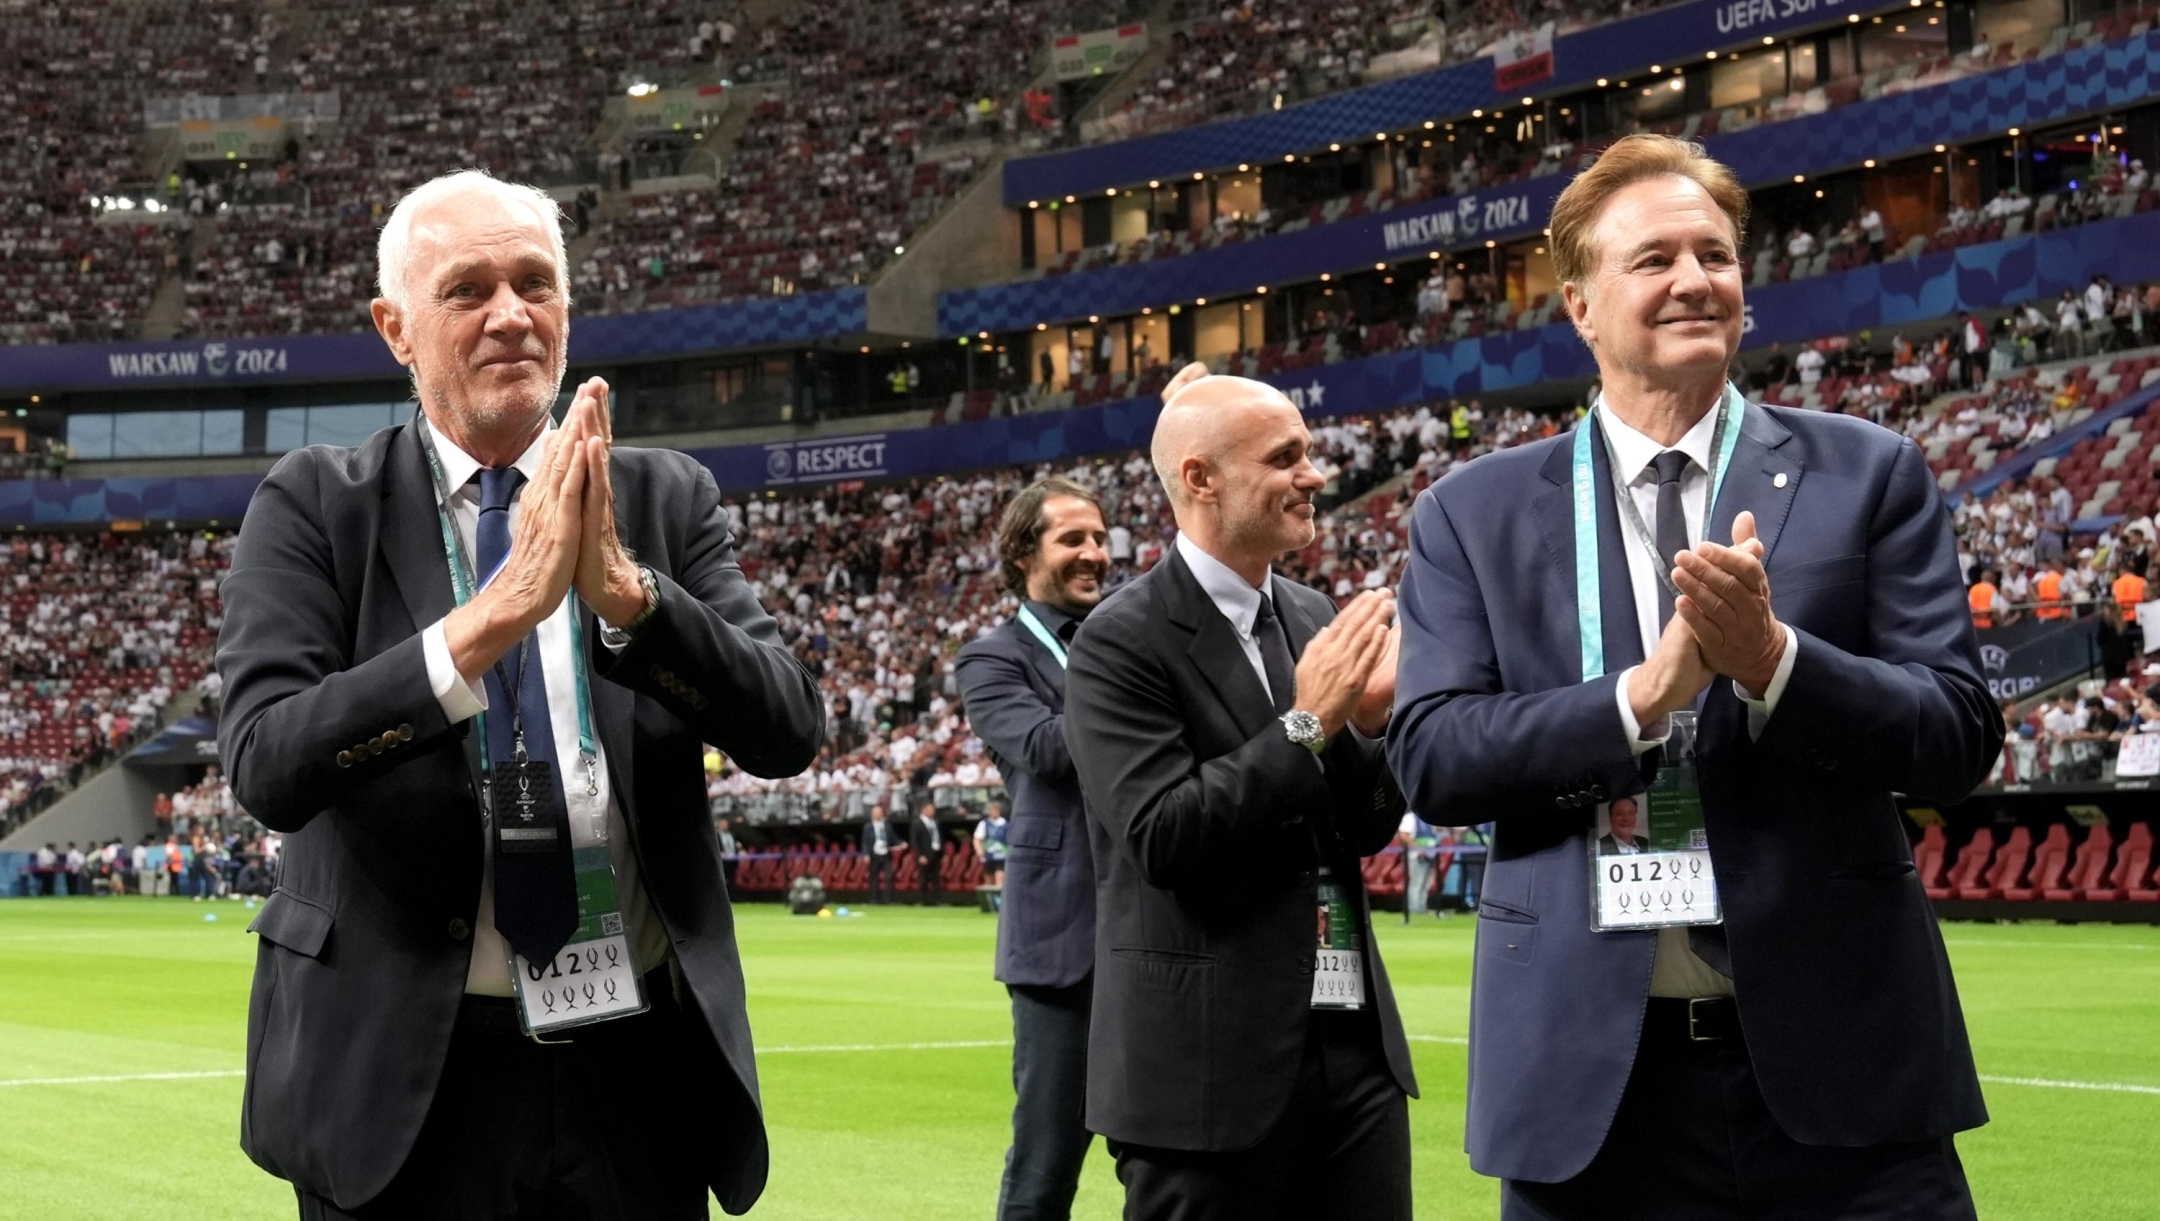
left=1110, top=1009, right=1410, bottom=1221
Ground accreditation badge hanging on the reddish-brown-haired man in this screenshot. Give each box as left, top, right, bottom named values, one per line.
left=1588, top=711, right=1724, bottom=931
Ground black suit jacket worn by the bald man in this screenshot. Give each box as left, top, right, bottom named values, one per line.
left=1065, top=551, right=1417, bottom=1152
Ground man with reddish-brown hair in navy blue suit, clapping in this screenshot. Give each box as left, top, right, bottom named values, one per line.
left=1389, top=136, right=2002, bottom=1221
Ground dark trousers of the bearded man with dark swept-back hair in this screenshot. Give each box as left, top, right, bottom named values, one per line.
left=998, top=977, right=1095, bottom=1221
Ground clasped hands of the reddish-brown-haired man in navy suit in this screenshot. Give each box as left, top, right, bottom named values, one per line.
left=1626, top=512, right=1784, bottom=726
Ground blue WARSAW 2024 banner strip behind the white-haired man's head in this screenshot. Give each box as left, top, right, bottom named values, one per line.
left=0, top=287, right=868, bottom=393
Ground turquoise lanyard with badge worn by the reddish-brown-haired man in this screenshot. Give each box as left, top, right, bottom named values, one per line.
left=1572, top=383, right=1747, bottom=931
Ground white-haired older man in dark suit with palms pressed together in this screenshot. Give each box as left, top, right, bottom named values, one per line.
left=218, top=173, right=825, bottom=1219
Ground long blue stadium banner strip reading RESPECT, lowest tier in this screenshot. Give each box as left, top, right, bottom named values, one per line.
left=12, top=212, right=2160, bottom=525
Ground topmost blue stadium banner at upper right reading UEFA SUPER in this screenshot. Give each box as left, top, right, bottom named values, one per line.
left=1002, top=0, right=1909, bottom=207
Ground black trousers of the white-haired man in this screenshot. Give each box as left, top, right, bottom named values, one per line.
left=298, top=968, right=726, bottom=1221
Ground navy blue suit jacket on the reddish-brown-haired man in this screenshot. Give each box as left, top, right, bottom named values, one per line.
left=1389, top=404, right=2002, bottom=1182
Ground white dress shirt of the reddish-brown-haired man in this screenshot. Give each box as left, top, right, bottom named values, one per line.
left=1596, top=400, right=1799, bottom=996
